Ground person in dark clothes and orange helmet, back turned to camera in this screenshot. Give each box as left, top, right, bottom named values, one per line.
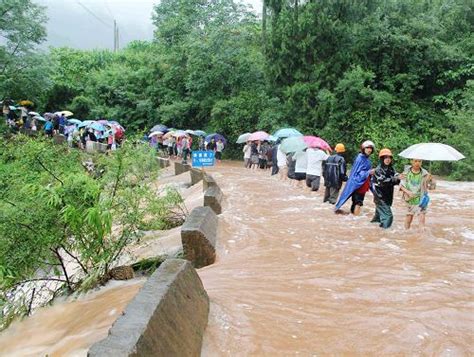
left=323, top=143, right=347, bottom=205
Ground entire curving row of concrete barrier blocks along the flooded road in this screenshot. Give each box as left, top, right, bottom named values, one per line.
left=88, top=165, right=223, bottom=357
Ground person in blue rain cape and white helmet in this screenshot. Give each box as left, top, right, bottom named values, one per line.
left=335, top=140, right=375, bottom=216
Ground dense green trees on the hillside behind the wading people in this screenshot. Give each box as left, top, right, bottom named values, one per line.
left=2, top=0, right=474, bottom=179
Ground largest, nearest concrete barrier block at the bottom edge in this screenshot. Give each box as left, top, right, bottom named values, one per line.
left=88, top=259, right=209, bottom=357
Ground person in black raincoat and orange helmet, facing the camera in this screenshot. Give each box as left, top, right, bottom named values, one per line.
left=371, top=149, right=400, bottom=229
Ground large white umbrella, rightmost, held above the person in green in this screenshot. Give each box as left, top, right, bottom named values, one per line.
left=399, top=143, right=465, bottom=161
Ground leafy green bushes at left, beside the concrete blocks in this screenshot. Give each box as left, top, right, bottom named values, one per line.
left=0, top=135, right=185, bottom=327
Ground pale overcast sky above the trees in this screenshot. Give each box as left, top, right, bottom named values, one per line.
left=34, top=0, right=262, bottom=49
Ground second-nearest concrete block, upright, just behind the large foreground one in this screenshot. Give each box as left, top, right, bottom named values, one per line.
left=181, top=207, right=217, bottom=268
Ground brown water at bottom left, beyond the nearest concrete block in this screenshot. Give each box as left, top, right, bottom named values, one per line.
left=0, top=279, right=144, bottom=357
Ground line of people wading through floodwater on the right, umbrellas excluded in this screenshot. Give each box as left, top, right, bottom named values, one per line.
left=243, top=140, right=432, bottom=229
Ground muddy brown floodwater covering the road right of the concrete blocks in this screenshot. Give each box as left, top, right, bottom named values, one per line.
left=199, top=164, right=474, bottom=356
